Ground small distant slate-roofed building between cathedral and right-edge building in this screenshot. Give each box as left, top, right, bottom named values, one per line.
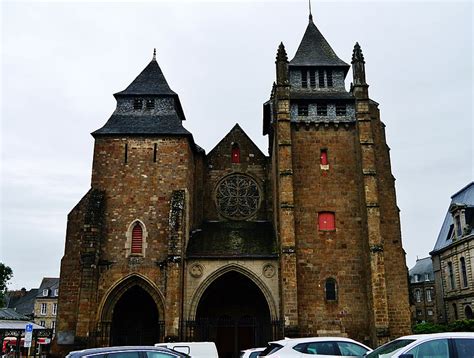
left=409, top=257, right=437, bottom=323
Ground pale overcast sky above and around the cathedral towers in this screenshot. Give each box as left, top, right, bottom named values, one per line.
left=0, top=0, right=474, bottom=289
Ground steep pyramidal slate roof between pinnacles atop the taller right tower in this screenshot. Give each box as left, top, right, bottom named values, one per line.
left=289, top=17, right=349, bottom=73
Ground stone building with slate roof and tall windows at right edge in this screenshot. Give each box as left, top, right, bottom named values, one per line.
left=430, top=182, right=474, bottom=323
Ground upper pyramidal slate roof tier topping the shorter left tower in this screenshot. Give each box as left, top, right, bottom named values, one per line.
left=114, top=58, right=177, bottom=96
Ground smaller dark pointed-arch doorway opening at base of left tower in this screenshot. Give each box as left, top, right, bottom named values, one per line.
left=110, top=285, right=160, bottom=346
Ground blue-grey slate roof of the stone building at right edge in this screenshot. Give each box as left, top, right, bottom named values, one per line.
left=430, top=182, right=474, bottom=255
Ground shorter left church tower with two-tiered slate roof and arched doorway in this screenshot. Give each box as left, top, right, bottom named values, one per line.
left=53, top=54, right=203, bottom=356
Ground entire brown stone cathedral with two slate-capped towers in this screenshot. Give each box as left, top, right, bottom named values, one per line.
left=53, top=11, right=410, bottom=357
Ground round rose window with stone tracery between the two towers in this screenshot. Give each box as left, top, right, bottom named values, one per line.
left=216, top=174, right=260, bottom=220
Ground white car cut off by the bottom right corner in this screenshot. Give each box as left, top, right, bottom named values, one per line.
left=366, top=332, right=474, bottom=358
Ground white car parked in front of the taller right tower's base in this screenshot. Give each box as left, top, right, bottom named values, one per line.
left=260, top=337, right=372, bottom=358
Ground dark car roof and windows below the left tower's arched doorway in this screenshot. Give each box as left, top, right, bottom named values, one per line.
left=66, top=346, right=189, bottom=358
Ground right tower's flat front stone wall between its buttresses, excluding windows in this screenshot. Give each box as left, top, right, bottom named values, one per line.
left=292, top=124, right=369, bottom=342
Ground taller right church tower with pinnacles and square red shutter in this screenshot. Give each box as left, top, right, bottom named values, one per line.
left=263, top=14, right=410, bottom=346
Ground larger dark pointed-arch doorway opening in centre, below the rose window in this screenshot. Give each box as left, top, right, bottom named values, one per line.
left=196, top=271, right=271, bottom=358
